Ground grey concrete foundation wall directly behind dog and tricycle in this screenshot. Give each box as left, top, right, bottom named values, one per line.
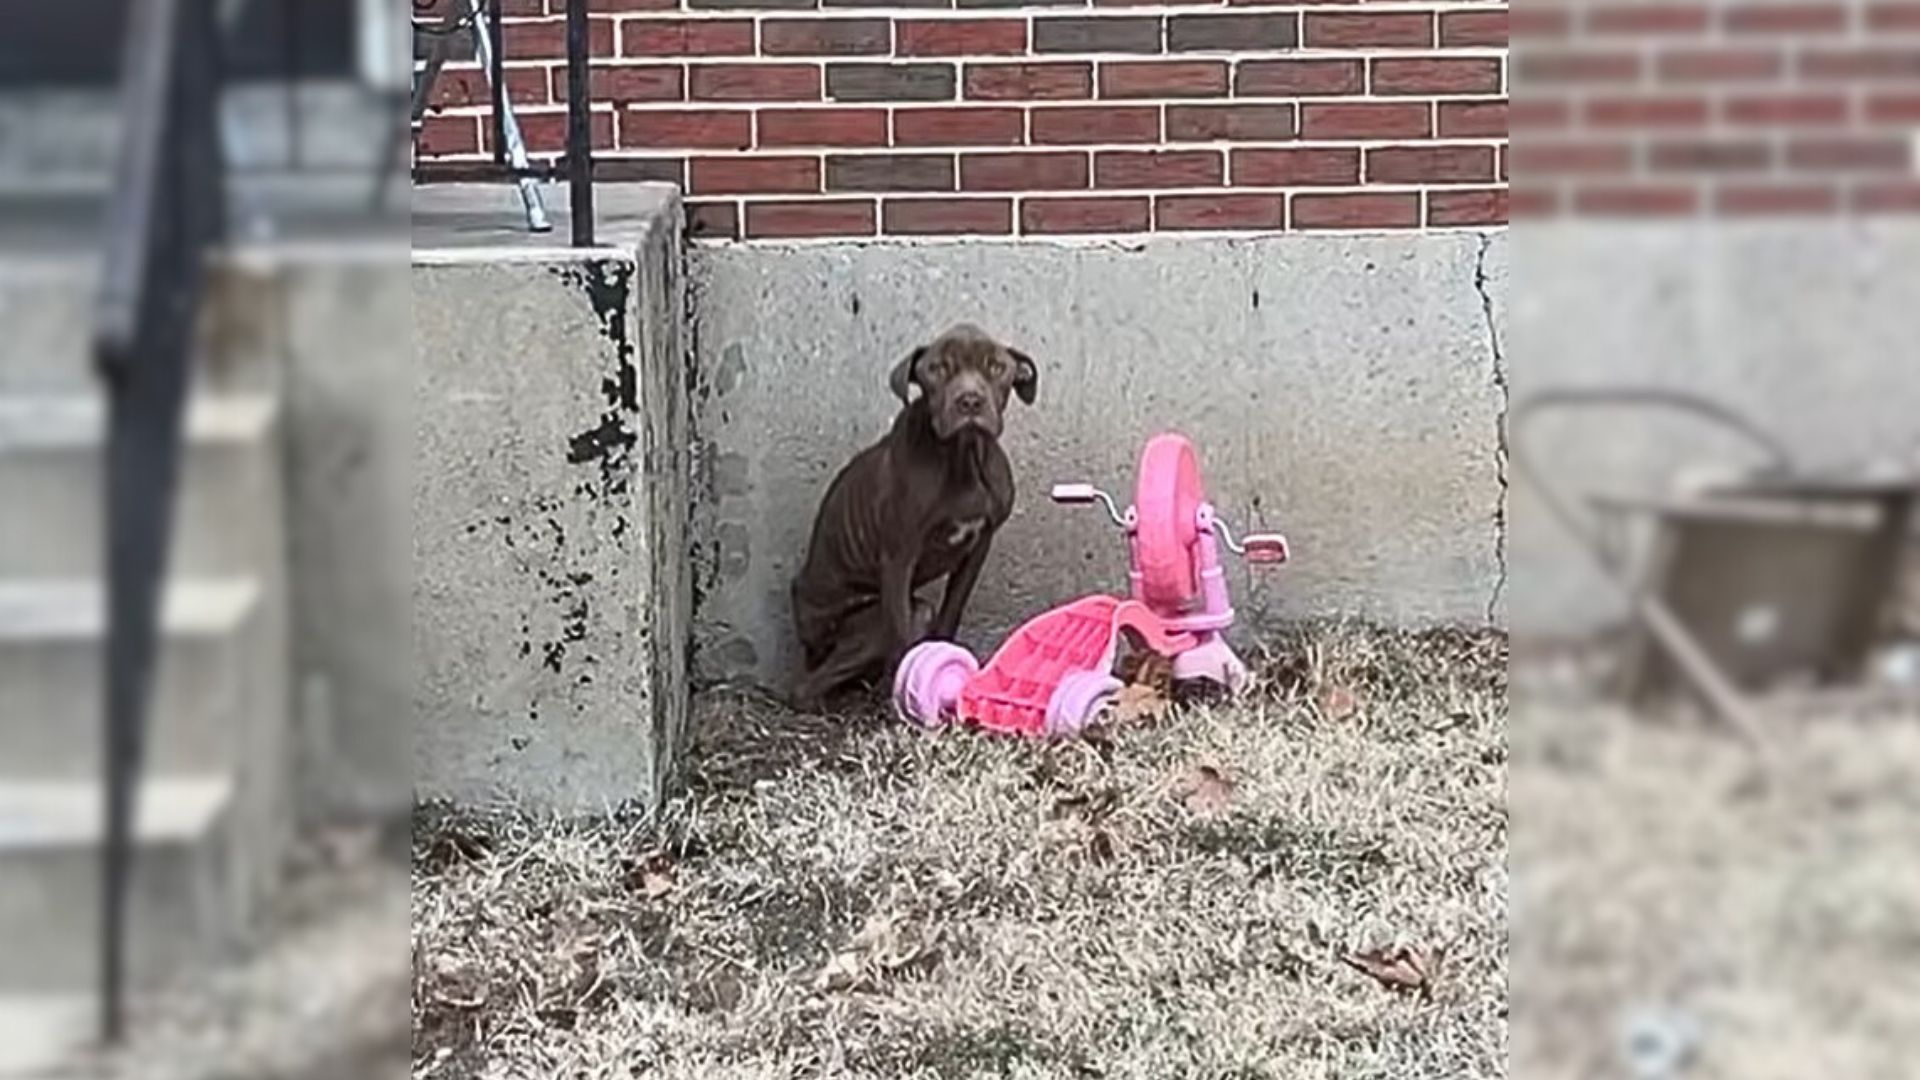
left=691, top=233, right=1507, bottom=684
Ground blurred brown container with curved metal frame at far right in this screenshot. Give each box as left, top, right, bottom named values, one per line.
left=1509, top=388, right=1920, bottom=749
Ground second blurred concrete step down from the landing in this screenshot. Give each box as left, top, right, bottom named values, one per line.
left=0, top=578, right=261, bottom=780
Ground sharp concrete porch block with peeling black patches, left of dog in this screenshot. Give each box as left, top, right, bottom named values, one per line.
left=411, top=188, right=691, bottom=811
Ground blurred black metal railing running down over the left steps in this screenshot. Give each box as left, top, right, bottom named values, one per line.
left=94, top=0, right=227, bottom=1043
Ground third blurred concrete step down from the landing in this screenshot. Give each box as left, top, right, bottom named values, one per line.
left=0, top=776, right=248, bottom=1001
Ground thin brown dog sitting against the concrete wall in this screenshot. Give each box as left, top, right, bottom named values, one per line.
left=793, top=325, right=1041, bottom=709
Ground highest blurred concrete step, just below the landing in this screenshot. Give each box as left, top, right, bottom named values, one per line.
left=0, top=392, right=282, bottom=578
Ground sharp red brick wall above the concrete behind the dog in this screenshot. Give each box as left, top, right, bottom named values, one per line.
left=420, top=0, right=1507, bottom=238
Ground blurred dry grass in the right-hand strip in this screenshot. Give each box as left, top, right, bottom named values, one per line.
left=1511, top=694, right=1920, bottom=1080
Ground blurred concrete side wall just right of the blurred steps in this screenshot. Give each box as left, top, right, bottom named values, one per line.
left=167, top=244, right=413, bottom=821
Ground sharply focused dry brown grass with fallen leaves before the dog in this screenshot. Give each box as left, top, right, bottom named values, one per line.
left=413, top=628, right=1507, bottom=1080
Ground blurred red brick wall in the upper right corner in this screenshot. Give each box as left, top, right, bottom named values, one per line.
left=1513, top=0, right=1920, bottom=217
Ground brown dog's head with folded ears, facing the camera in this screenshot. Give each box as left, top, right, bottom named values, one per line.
left=889, top=323, right=1041, bottom=438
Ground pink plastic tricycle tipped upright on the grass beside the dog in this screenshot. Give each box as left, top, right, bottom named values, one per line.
left=893, top=434, right=1288, bottom=736
